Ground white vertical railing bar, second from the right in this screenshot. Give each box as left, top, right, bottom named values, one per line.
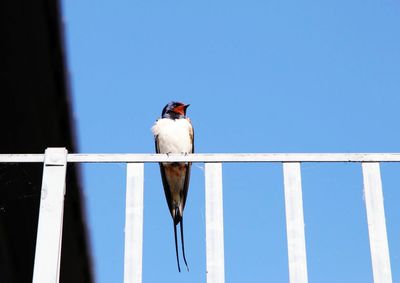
left=283, top=162, right=308, bottom=283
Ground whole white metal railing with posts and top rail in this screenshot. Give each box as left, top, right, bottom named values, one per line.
left=0, top=148, right=400, bottom=283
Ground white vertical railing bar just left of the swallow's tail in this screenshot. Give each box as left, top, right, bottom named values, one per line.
left=124, top=163, right=144, bottom=283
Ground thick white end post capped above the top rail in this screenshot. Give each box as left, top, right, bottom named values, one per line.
left=32, top=148, right=67, bottom=283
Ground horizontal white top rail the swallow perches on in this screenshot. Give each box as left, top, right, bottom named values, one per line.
left=0, top=153, right=400, bottom=163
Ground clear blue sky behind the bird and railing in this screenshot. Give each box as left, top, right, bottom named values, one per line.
left=63, top=0, right=400, bottom=283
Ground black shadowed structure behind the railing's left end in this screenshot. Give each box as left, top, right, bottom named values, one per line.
left=0, top=0, right=93, bottom=283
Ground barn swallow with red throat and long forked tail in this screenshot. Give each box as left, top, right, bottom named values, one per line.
left=152, top=101, right=194, bottom=272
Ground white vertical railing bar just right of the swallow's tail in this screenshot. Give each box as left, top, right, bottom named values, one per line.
left=205, top=163, right=225, bottom=283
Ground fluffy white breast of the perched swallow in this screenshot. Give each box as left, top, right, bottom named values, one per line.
left=151, top=118, right=192, bottom=153
